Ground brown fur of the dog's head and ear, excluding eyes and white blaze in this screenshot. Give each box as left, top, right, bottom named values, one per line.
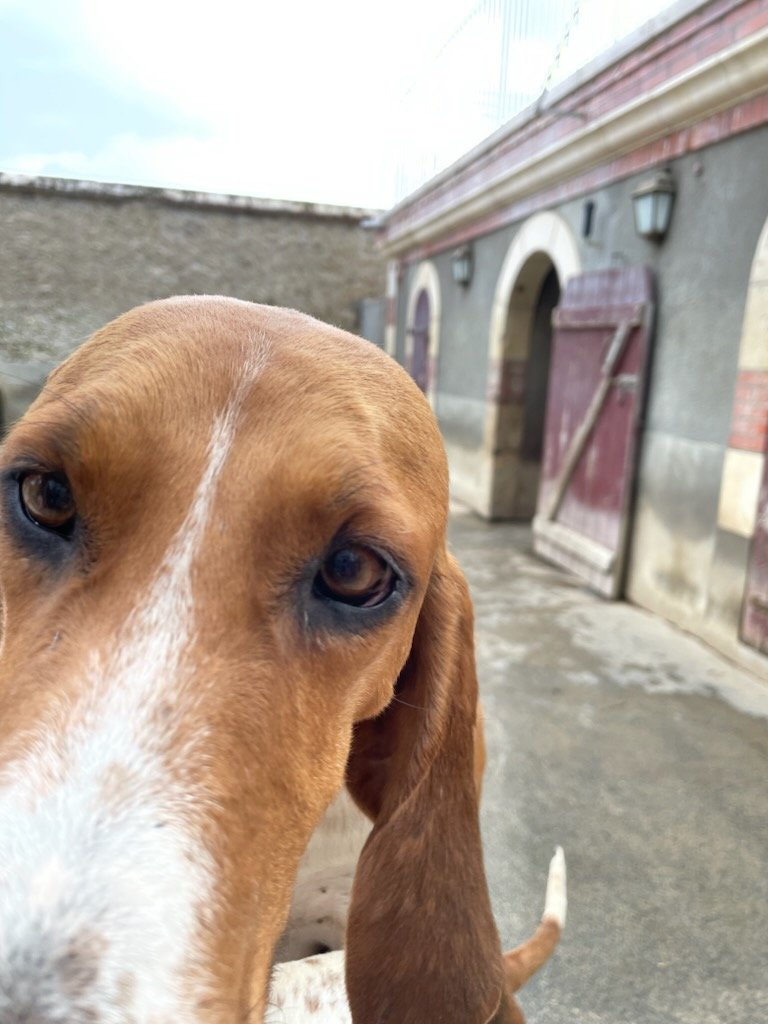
left=0, top=298, right=561, bottom=1024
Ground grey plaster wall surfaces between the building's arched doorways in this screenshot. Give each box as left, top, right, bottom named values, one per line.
left=393, top=121, right=768, bottom=653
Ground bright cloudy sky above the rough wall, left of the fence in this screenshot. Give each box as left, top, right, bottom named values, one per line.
left=0, top=0, right=667, bottom=208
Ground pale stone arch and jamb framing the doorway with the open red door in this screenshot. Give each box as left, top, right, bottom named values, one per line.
left=483, top=211, right=582, bottom=518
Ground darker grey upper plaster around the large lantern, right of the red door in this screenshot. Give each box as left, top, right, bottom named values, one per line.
left=548, top=128, right=768, bottom=444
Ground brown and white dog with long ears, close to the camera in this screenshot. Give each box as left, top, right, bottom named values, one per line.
left=0, top=298, right=564, bottom=1024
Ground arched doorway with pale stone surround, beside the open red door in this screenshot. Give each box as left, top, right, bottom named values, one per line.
left=485, top=212, right=581, bottom=519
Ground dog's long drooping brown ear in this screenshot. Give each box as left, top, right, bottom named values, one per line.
left=347, top=555, right=512, bottom=1024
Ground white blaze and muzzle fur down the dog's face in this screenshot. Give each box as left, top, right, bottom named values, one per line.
left=0, top=356, right=264, bottom=1024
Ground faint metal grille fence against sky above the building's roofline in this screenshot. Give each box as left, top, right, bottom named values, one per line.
left=395, top=0, right=671, bottom=201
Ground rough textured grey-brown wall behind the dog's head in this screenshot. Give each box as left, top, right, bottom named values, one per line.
left=0, top=178, right=385, bottom=361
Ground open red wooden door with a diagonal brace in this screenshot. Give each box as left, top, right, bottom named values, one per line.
left=534, top=266, right=654, bottom=597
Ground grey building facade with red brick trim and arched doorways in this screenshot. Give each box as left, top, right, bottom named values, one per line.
left=380, top=0, right=768, bottom=679
